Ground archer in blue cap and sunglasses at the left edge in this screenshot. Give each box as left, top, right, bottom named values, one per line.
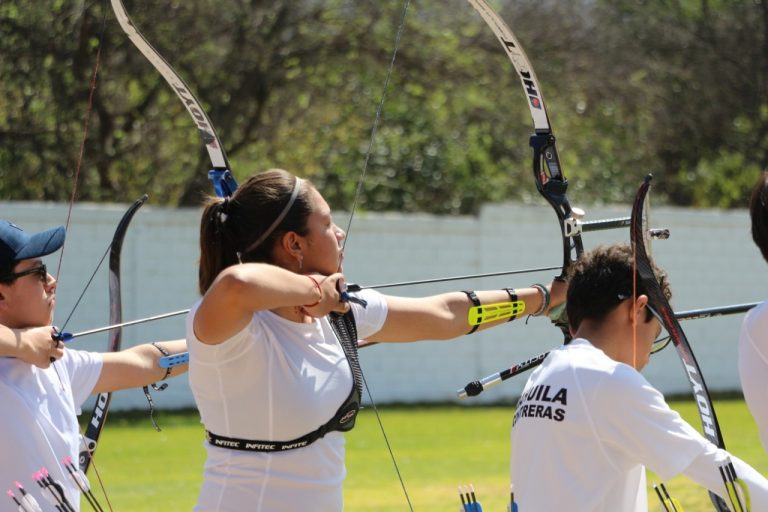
left=0, top=220, right=186, bottom=510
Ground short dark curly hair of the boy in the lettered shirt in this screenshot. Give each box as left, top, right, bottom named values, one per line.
left=566, top=244, right=672, bottom=330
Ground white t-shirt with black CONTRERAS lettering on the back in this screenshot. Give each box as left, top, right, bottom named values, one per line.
left=511, top=339, right=716, bottom=512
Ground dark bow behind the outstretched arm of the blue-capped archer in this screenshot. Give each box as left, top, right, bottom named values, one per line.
left=79, top=194, right=147, bottom=472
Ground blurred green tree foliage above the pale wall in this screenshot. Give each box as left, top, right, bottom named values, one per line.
left=0, top=0, right=768, bottom=213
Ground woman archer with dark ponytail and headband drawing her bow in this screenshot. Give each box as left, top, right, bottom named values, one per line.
left=187, top=169, right=565, bottom=512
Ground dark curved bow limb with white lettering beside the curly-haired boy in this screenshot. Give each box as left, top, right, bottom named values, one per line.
left=630, top=175, right=729, bottom=512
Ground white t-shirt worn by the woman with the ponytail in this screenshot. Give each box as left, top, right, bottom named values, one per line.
left=187, top=290, right=387, bottom=512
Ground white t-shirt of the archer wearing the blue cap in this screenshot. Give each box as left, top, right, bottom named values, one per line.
left=0, top=349, right=102, bottom=511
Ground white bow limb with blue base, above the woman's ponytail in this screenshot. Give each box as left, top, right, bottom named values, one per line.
left=110, top=0, right=237, bottom=197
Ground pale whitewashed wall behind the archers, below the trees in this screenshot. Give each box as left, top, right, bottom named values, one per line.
left=0, top=201, right=768, bottom=408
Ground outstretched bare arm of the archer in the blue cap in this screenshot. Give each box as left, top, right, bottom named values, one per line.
left=93, top=339, right=189, bottom=393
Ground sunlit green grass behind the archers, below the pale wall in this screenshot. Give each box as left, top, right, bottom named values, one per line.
left=83, top=400, right=768, bottom=512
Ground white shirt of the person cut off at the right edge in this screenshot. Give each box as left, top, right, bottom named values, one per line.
left=739, top=302, right=768, bottom=451
